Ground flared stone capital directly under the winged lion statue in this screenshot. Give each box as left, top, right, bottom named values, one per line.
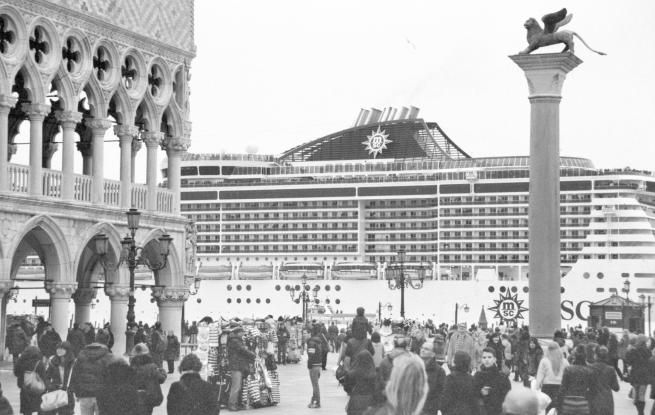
left=509, top=52, right=582, bottom=98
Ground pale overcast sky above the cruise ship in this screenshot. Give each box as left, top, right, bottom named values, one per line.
left=190, top=0, right=655, bottom=170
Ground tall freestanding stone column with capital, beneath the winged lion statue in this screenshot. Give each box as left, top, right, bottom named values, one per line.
left=510, top=53, right=582, bottom=338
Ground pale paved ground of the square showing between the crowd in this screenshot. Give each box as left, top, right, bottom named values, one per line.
left=0, top=353, right=653, bottom=415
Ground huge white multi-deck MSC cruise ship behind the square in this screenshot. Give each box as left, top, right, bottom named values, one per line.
left=172, top=107, right=655, bottom=329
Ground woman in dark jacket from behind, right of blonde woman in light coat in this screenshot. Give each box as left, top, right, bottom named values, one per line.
left=557, top=344, right=596, bottom=415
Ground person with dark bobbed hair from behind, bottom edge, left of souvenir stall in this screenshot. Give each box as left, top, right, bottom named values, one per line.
left=166, top=353, right=219, bottom=415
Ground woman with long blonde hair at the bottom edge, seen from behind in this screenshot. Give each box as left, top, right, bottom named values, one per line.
left=366, top=353, right=428, bottom=415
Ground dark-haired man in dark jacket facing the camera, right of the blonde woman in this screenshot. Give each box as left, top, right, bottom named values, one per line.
left=473, top=347, right=512, bottom=415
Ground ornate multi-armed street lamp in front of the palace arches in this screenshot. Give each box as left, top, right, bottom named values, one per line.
left=95, top=209, right=173, bottom=326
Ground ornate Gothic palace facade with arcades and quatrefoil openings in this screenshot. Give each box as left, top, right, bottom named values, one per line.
left=0, top=0, right=195, bottom=353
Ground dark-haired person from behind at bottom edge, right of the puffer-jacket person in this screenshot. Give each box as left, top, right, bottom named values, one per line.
left=97, top=358, right=139, bottom=415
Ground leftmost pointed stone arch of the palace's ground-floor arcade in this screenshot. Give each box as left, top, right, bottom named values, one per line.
left=7, top=215, right=72, bottom=282
